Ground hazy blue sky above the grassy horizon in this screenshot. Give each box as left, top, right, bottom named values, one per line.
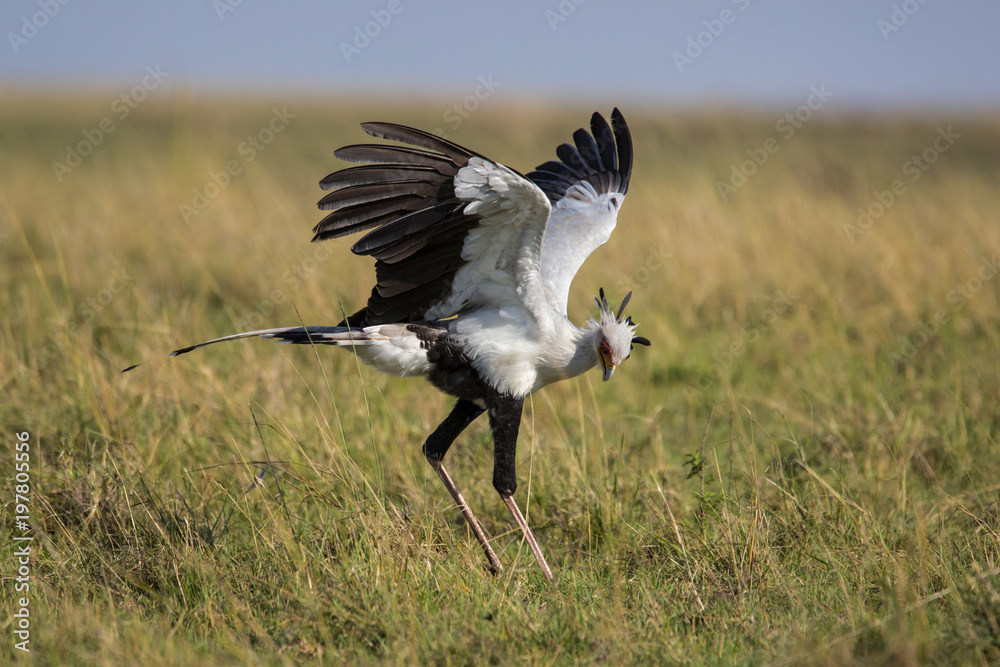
left=0, top=0, right=1000, bottom=109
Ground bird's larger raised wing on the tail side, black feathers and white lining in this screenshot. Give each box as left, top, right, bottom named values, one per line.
left=313, top=123, right=551, bottom=326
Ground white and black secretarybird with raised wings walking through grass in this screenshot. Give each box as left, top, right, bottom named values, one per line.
left=171, top=109, right=649, bottom=579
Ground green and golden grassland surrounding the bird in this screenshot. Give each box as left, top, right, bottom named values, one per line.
left=0, top=93, right=1000, bottom=665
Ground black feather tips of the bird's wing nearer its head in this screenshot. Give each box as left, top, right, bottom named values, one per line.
left=527, top=107, right=632, bottom=203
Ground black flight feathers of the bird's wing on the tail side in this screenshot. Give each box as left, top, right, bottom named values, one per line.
left=310, top=122, right=485, bottom=328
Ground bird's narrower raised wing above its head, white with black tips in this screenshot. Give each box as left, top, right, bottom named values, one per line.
left=528, top=108, right=632, bottom=315
